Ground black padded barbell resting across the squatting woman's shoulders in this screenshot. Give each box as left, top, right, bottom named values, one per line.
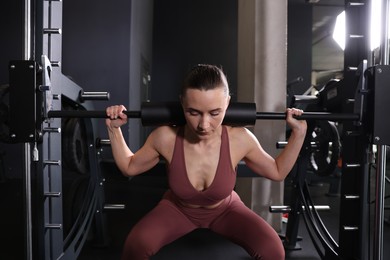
left=47, top=102, right=360, bottom=126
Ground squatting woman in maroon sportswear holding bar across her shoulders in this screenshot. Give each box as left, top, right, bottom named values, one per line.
left=106, top=65, right=307, bottom=260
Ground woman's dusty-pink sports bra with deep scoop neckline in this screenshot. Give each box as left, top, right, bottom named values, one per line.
left=168, top=126, right=237, bottom=206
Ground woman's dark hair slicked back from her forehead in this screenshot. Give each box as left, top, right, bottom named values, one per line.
left=181, top=64, right=230, bottom=96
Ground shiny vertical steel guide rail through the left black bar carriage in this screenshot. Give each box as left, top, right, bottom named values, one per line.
left=23, top=0, right=32, bottom=260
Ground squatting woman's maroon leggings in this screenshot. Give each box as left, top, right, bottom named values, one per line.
left=122, top=191, right=284, bottom=260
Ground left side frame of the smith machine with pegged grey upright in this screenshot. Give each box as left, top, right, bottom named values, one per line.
left=15, top=0, right=108, bottom=259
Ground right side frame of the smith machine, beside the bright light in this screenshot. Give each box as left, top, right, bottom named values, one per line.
left=270, top=0, right=390, bottom=259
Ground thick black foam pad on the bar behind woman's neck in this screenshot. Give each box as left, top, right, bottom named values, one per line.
left=141, top=102, right=256, bottom=126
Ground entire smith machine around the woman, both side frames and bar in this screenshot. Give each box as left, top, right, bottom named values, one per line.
left=3, top=0, right=390, bottom=259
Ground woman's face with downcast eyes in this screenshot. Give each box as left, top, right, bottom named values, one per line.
left=182, top=87, right=230, bottom=139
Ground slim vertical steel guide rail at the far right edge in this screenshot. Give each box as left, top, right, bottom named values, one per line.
left=374, top=0, right=390, bottom=260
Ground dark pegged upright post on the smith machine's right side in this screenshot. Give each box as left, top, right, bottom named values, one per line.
left=339, top=0, right=371, bottom=259
